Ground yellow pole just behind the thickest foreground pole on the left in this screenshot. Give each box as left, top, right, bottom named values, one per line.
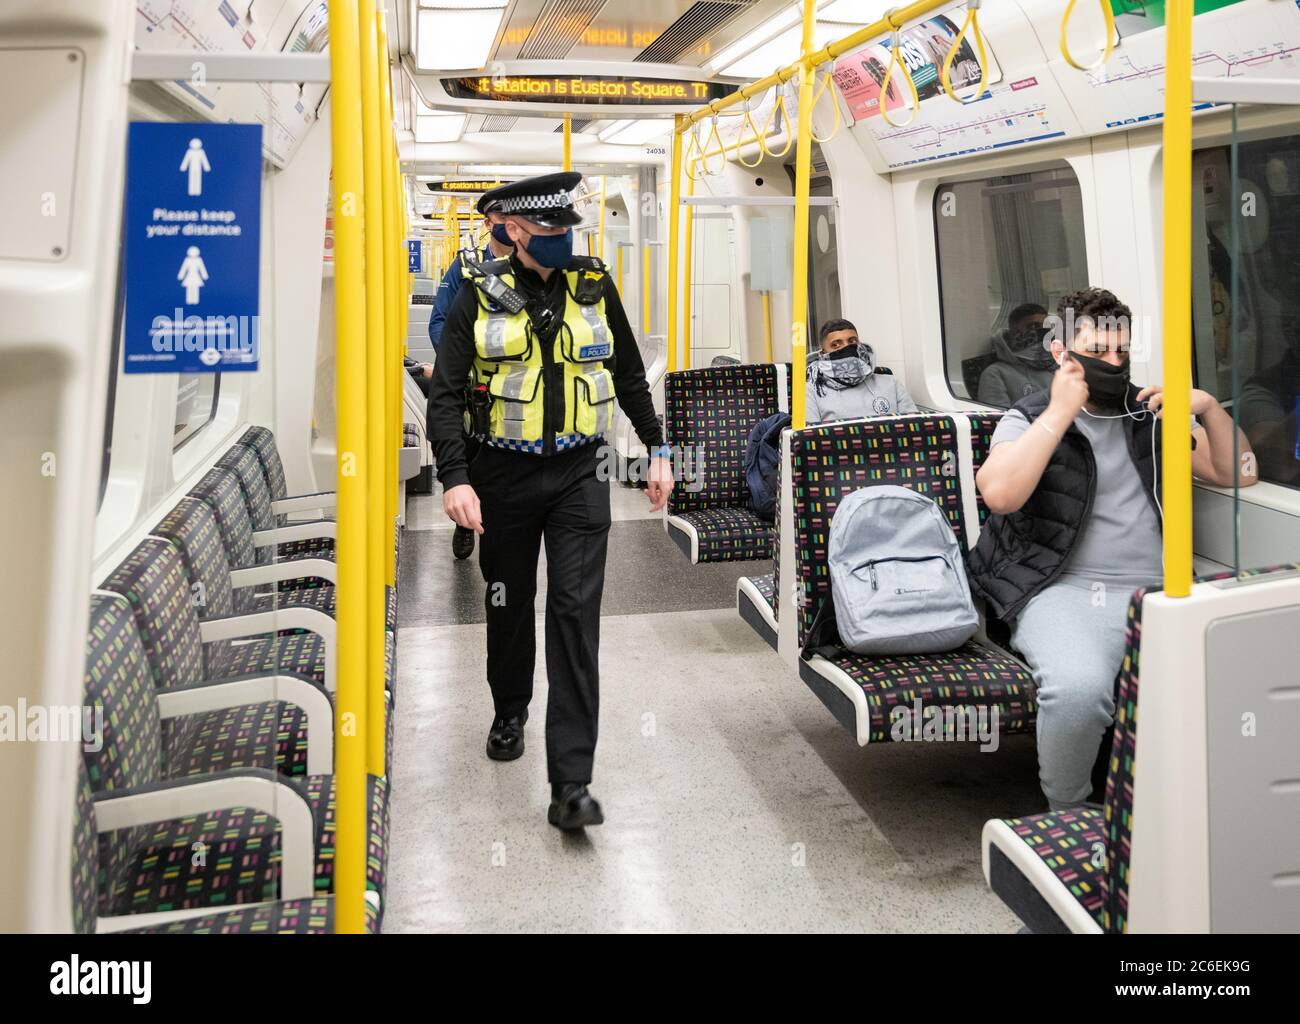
left=358, top=0, right=387, bottom=776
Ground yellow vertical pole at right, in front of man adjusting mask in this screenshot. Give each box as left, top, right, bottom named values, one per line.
left=1160, top=0, right=1190, bottom=598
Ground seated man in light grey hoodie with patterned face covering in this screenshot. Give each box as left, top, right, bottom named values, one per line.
left=805, top=320, right=918, bottom=424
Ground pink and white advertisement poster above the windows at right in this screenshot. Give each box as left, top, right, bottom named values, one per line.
left=835, top=14, right=1002, bottom=121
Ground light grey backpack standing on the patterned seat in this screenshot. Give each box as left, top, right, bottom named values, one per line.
left=827, top=485, right=979, bottom=655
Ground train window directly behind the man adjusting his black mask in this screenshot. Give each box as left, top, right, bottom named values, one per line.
left=935, top=164, right=1088, bottom=407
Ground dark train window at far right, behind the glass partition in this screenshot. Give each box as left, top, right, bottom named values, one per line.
left=1192, top=135, right=1300, bottom=489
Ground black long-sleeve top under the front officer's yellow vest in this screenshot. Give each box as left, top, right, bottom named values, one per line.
left=426, top=256, right=663, bottom=487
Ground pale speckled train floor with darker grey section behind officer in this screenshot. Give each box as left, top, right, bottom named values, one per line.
left=385, top=475, right=1044, bottom=933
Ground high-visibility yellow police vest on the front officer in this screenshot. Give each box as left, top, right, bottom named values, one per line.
left=473, top=263, right=615, bottom=451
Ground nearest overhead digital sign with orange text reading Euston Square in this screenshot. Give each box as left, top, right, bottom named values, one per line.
left=442, top=75, right=736, bottom=107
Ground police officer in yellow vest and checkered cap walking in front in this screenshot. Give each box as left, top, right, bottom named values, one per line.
left=429, top=172, right=672, bottom=830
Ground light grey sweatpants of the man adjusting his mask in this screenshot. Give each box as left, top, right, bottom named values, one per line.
left=1011, top=581, right=1138, bottom=810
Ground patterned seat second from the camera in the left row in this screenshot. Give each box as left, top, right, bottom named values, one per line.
left=77, top=595, right=387, bottom=915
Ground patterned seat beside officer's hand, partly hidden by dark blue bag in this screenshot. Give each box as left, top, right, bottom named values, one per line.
left=664, top=364, right=790, bottom=561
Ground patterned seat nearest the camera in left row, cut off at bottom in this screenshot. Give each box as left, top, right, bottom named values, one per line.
left=72, top=759, right=380, bottom=934
